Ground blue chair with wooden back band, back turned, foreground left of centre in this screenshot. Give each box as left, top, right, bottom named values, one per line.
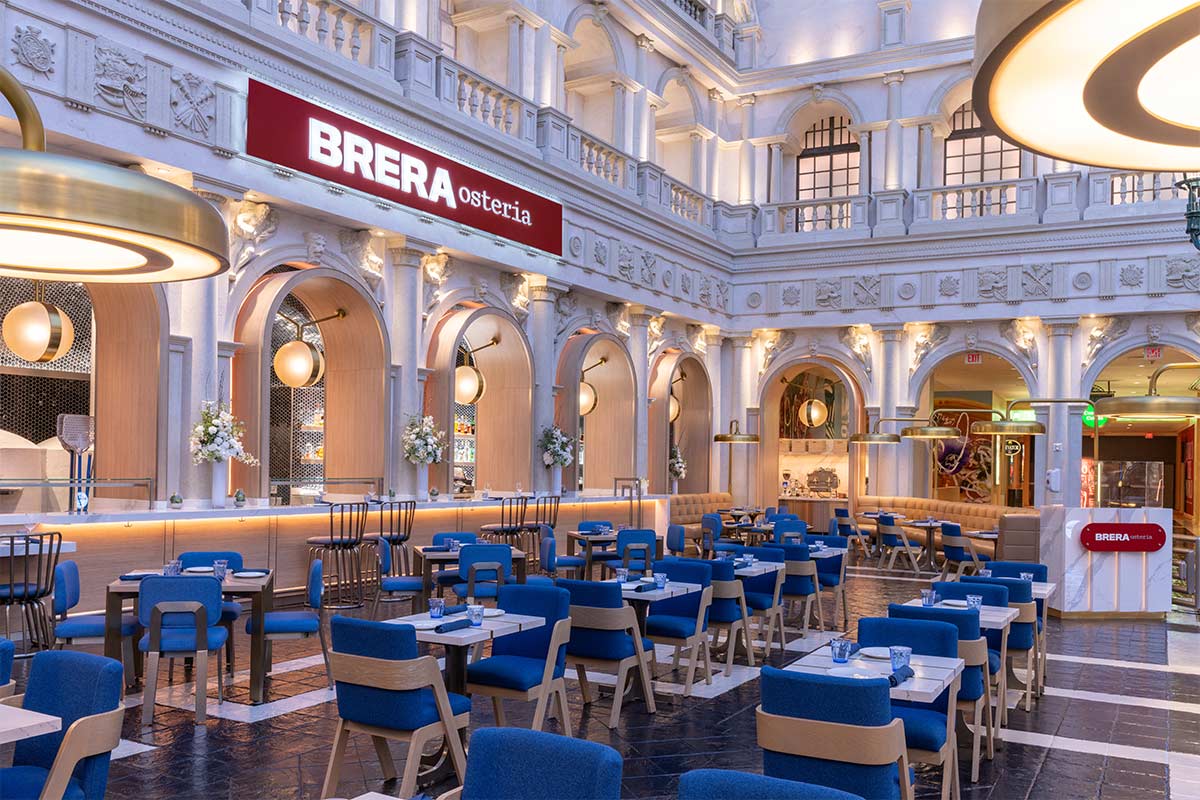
left=320, top=615, right=470, bottom=798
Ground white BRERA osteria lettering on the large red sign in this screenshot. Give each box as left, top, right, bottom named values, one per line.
left=308, top=118, right=465, bottom=215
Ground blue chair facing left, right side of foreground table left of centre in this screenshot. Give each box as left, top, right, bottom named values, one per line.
left=467, top=582, right=571, bottom=736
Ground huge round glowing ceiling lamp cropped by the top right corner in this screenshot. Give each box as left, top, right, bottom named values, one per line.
left=972, top=0, right=1200, bottom=172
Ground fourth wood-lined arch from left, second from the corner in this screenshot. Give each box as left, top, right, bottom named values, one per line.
left=554, top=331, right=637, bottom=493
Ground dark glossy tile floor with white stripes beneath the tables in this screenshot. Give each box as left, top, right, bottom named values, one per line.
left=11, top=569, right=1200, bottom=800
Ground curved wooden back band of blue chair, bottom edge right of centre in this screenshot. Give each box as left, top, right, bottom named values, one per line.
left=755, top=703, right=913, bottom=800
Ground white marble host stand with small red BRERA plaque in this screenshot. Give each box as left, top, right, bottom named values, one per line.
left=1042, top=506, right=1171, bottom=618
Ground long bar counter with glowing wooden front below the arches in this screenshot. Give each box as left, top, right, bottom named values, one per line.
left=0, top=495, right=671, bottom=610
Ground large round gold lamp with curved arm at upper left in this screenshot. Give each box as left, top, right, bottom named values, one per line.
left=0, top=67, right=229, bottom=283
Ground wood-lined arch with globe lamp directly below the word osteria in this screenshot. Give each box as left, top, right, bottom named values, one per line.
left=425, top=303, right=534, bottom=493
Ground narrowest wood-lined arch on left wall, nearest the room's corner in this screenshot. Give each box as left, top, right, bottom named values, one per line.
left=648, top=350, right=713, bottom=494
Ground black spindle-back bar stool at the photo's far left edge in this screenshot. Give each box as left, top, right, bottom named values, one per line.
left=0, top=531, right=62, bottom=656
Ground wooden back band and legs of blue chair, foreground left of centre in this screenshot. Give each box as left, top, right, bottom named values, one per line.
left=320, top=651, right=470, bottom=799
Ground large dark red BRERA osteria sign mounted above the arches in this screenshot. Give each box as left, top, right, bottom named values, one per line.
left=246, top=80, right=563, bottom=255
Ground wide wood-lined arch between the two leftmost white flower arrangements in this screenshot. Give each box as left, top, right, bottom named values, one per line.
left=230, top=266, right=390, bottom=503
